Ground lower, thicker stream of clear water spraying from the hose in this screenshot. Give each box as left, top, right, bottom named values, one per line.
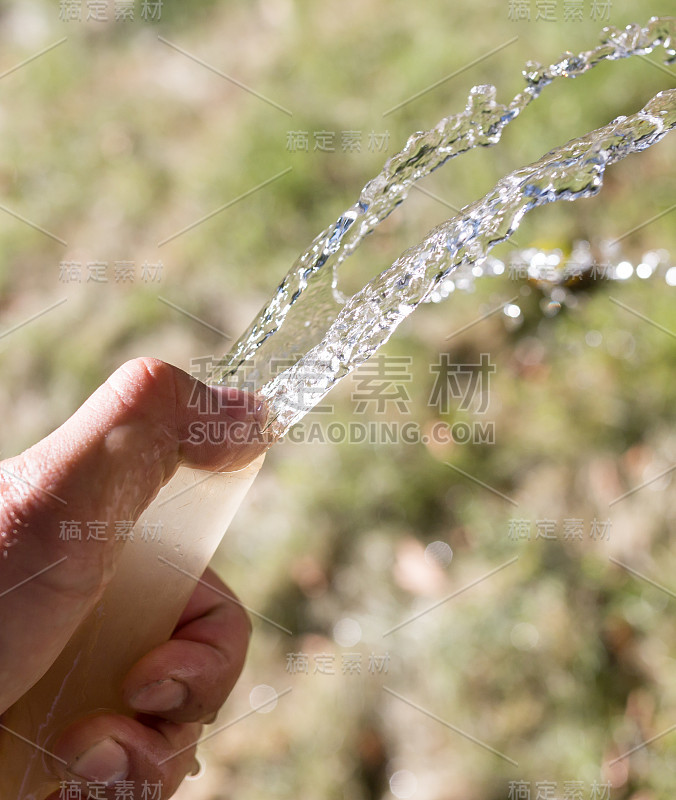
left=261, top=89, right=676, bottom=435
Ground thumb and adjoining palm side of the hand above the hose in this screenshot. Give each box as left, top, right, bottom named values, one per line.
left=0, top=358, right=270, bottom=713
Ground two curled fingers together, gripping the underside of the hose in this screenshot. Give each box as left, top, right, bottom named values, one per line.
left=48, top=570, right=250, bottom=800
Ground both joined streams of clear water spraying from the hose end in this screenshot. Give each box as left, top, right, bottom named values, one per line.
left=213, top=18, right=676, bottom=435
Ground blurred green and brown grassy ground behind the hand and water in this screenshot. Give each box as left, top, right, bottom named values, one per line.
left=0, top=0, right=676, bottom=800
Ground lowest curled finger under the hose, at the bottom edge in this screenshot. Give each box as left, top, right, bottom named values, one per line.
left=52, top=714, right=202, bottom=800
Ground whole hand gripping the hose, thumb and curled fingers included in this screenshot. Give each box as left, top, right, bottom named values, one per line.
left=0, top=359, right=267, bottom=798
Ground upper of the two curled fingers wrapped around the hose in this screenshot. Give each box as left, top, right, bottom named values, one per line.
left=122, top=570, right=251, bottom=722
